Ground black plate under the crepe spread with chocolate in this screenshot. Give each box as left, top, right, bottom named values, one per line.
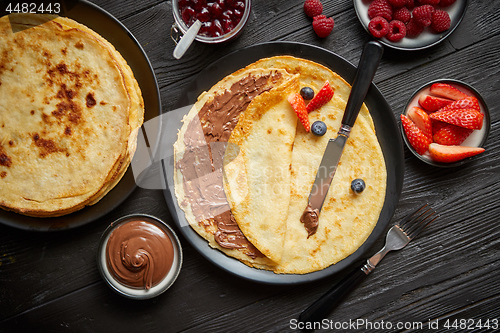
left=161, top=42, right=404, bottom=284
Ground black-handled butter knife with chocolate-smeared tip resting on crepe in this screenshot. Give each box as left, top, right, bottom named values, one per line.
left=301, top=41, right=384, bottom=221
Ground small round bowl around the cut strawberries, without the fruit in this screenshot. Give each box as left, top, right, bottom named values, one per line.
left=400, top=79, right=491, bottom=168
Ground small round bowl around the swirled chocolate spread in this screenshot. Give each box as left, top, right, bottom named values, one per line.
left=97, top=214, right=182, bottom=300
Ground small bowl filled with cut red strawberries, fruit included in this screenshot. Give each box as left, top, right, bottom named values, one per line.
left=401, top=79, right=491, bottom=167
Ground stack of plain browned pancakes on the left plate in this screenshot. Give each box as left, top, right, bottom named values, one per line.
left=0, top=14, right=144, bottom=217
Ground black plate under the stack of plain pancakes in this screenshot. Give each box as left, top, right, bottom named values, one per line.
left=0, top=1, right=161, bottom=231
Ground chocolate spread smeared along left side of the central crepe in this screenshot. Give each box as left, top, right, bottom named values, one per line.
left=176, top=72, right=281, bottom=258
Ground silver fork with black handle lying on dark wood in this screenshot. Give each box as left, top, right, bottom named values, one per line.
left=299, top=204, right=439, bottom=323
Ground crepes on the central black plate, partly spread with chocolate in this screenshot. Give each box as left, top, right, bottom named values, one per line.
left=174, top=56, right=387, bottom=274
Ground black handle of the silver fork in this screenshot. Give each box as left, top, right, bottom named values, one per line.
left=299, top=265, right=370, bottom=323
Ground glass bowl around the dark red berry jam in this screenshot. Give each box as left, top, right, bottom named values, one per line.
left=170, top=0, right=252, bottom=44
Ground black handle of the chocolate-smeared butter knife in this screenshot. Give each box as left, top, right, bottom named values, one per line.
left=342, top=41, right=384, bottom=127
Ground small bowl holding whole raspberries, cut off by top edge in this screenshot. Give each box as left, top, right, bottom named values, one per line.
left=354, top=0, right=468, bottom=51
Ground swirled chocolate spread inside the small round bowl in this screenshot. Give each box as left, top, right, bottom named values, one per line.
left=106, top=221, right=174, bottom=289
